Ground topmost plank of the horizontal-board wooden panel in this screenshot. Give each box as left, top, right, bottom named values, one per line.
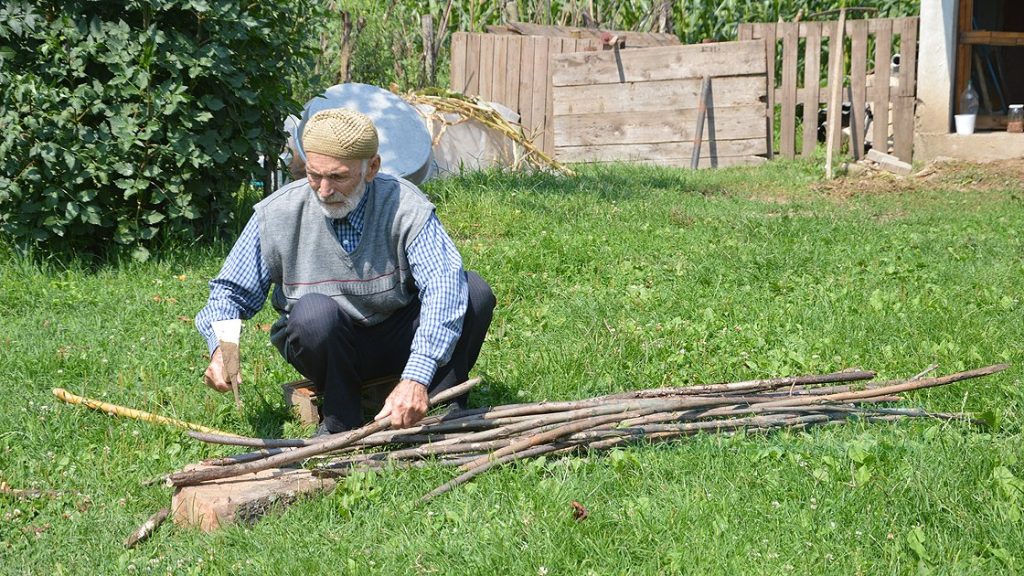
left=551, top=41, right=766, bottom=86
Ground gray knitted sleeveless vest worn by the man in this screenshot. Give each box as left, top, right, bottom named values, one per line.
left=255, top=174, right=434, bottom=351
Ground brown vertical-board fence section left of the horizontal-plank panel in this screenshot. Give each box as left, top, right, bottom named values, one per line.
left=452, top=32, right=601, bottom=155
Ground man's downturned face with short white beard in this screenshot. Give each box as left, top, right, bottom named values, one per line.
left=306, top=152, right=380, bottom=218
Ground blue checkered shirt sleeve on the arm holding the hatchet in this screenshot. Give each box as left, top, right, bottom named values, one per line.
left=196, top=214, right=270, bottom=356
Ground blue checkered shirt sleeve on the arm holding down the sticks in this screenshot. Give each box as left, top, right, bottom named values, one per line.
left=401, top=215, right=469, bottom=385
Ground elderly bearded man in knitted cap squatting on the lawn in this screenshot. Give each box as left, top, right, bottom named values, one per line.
left=196, top=109, right=495, bottom=436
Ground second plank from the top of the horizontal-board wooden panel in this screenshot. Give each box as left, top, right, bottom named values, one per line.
left=554, top=76, right=765, bottom=116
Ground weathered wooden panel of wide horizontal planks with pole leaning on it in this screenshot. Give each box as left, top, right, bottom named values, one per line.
left=551, top=41, right=768, bottom=167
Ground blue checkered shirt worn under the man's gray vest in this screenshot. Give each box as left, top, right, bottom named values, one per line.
left=196, top=188, right=469, bottom=384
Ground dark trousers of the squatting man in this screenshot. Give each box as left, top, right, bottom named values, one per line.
left=285, top=272, right=495, bottom=430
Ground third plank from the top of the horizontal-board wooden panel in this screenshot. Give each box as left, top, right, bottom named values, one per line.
left=554, top=106, right=765, bottom=147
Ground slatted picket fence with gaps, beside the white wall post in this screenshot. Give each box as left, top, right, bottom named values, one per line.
left=739, top=17, right=918, bottom=162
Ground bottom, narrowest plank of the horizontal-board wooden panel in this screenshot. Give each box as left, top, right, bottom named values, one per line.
left=555, top=138, right=768, bottom=162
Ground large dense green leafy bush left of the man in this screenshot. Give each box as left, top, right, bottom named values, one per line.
left=0, top=0, right=317, bottom=258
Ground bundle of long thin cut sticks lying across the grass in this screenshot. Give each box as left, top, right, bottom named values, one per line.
left=168, top=364, right=1008, bottom=501
